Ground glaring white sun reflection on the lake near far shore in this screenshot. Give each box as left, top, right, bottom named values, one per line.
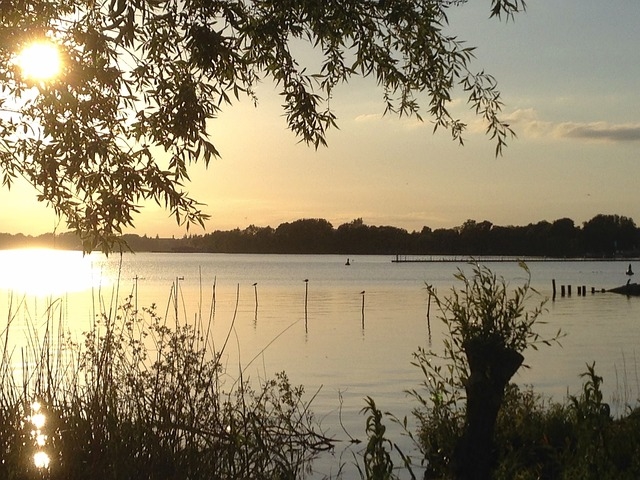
left=0, top=249, right=106, bottom=296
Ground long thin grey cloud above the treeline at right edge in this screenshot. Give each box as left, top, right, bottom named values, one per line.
left=505, top=108, right=640, bottom=142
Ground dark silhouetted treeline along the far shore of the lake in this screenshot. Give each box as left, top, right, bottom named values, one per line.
left=5, top=214, right=640, bottom=258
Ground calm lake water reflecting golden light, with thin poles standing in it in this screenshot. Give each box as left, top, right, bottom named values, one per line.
left=0, top=251, right=640, bottom=478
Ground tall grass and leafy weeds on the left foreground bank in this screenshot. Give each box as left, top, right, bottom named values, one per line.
left=0, top=282, right=333, bottom=480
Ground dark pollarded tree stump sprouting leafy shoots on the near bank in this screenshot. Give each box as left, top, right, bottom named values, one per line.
left=412, top=263, right=560, bottom=479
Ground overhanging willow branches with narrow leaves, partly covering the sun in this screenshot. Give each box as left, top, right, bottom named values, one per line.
left=0, top=0, right=525, bottom=251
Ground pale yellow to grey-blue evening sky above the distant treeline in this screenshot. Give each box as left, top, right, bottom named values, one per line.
left=0, top=0, right=640, bottom=237
